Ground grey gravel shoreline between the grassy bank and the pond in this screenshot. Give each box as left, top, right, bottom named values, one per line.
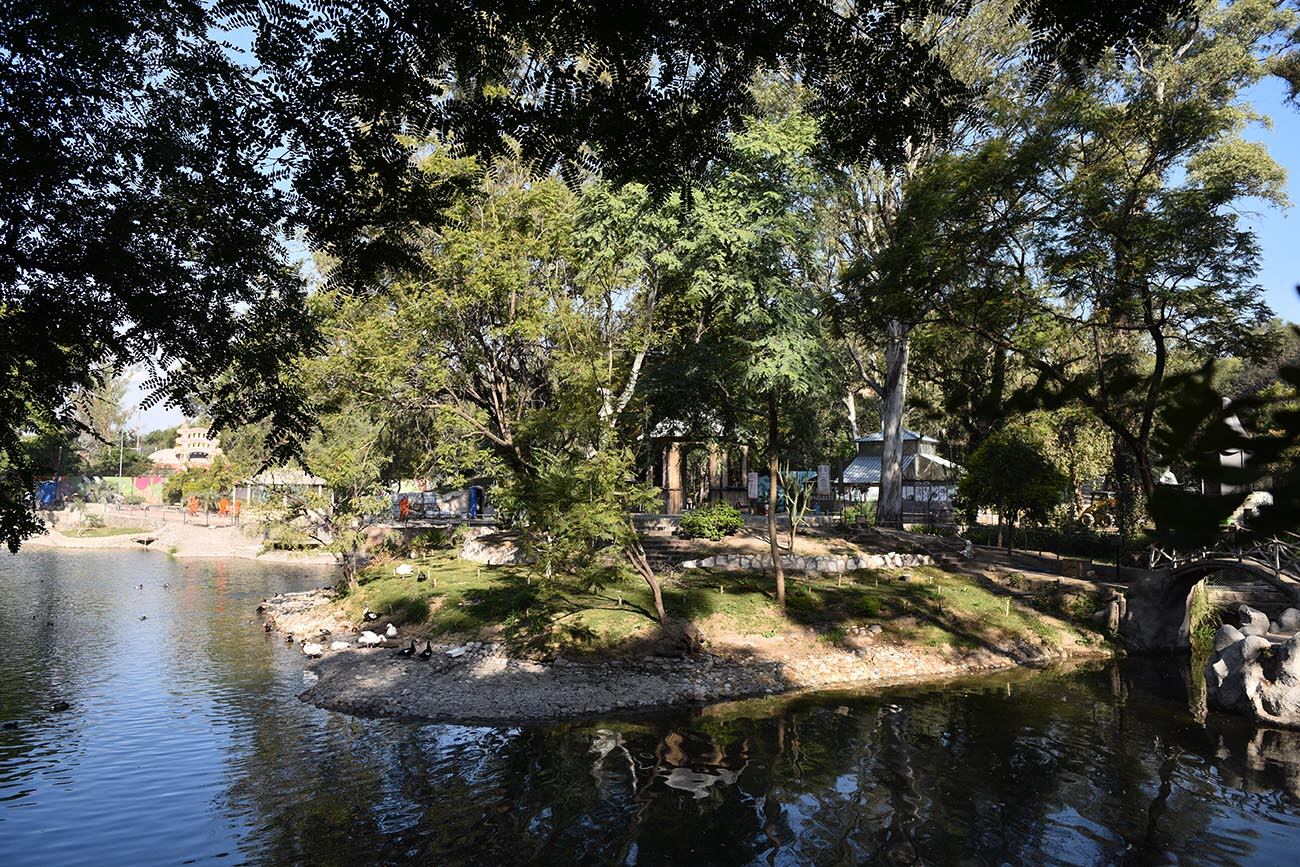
left=261, top=590, right=1110, bottom=724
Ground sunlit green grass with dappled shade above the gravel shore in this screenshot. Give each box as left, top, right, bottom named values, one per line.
left=337, top=551, right=1091, bottom=654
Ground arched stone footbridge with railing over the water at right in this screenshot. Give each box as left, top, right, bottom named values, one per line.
left=1119, top=533, right=1300, bottom=653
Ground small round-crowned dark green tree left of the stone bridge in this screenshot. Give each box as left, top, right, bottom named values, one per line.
left=958, top=430, right=1067, bottom=551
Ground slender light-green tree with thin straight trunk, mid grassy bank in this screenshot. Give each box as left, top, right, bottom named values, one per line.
left=659, top=103, right=827, bottom=607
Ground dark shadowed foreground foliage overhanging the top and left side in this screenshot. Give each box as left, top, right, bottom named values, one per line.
left=0, top=0, right=1196, bottom=549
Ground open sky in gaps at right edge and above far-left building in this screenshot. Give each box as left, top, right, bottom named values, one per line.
left=127, top=78, right=1300, bottom=430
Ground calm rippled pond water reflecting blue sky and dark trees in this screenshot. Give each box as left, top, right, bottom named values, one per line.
left=0, top=550, right=1300, bottom=867
